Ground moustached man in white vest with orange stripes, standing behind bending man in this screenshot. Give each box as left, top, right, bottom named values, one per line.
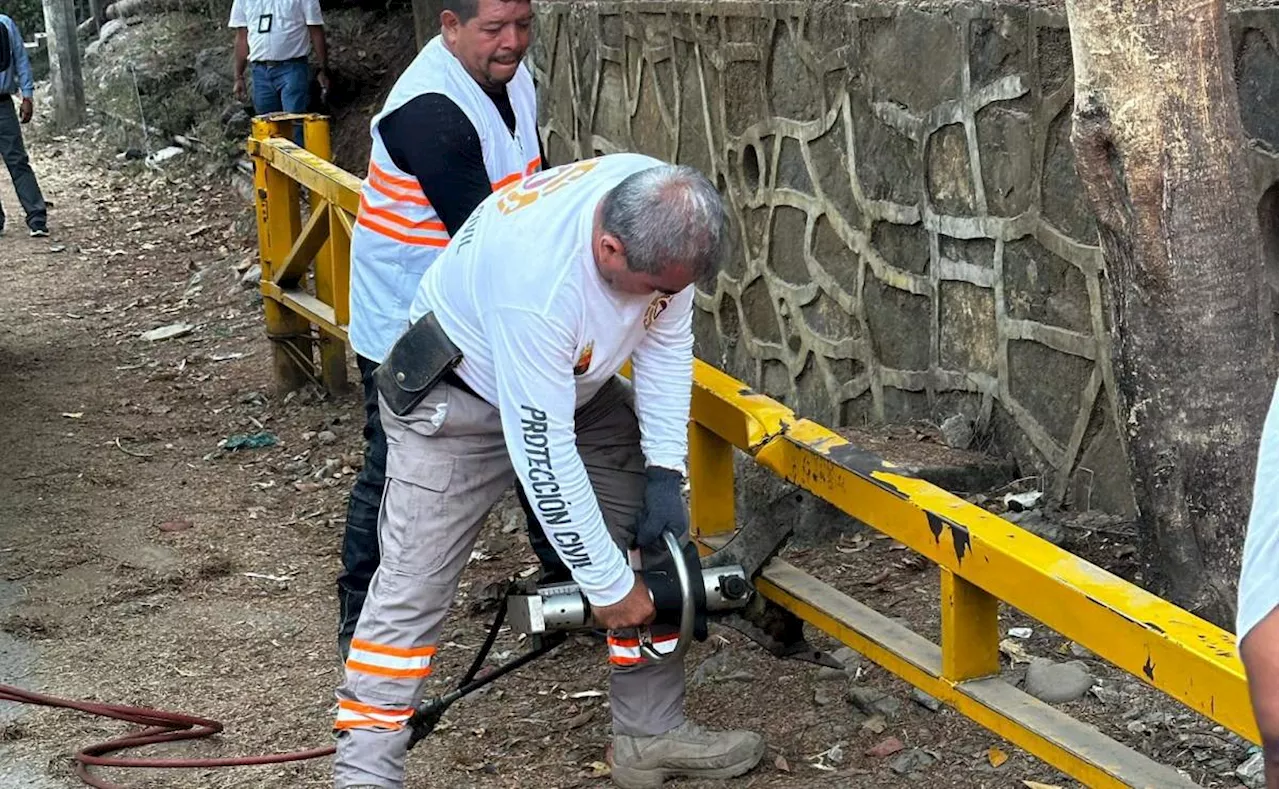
left=338, top=0, right=558, bottom=660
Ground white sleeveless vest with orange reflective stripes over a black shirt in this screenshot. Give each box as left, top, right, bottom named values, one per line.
left=347, top=36, right=541, bottom=362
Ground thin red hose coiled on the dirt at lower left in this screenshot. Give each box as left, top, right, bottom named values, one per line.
left=0, top=685, right=334, bottom=789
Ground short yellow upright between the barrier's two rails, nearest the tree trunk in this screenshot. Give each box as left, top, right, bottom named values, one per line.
left=942, top=567, right=1000, bottom=683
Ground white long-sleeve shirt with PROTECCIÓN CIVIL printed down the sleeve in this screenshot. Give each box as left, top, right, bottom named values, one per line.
left=410, top=154, right=694, bottom=606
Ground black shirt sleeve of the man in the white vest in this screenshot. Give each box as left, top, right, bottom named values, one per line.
left=378, top=94, right=493, bottom=236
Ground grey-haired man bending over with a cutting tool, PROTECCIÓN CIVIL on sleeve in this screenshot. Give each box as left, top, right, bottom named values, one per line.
left=334, top=154, right=764, bottom=789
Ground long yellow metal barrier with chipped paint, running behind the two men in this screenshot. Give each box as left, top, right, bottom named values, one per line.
left=248, top=115, right=1258, bottom=789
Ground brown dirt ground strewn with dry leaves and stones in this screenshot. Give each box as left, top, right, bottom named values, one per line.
left=0, top=124, right=1245, bottom=789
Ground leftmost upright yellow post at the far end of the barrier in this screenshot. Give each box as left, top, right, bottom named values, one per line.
left=253, top=118, right=312, bottom=393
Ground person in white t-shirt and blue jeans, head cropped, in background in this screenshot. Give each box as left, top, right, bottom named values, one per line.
left=227, top=0, right=329, bottom=128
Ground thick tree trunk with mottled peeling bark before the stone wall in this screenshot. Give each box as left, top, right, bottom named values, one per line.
left=1066, top=0, right=1275, bottom=625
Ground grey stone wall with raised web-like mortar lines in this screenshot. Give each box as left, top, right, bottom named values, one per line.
left=534, top=0, right=1280, bottom=512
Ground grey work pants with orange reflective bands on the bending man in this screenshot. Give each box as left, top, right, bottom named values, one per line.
left=334, top=378, right=687, bottom=789
